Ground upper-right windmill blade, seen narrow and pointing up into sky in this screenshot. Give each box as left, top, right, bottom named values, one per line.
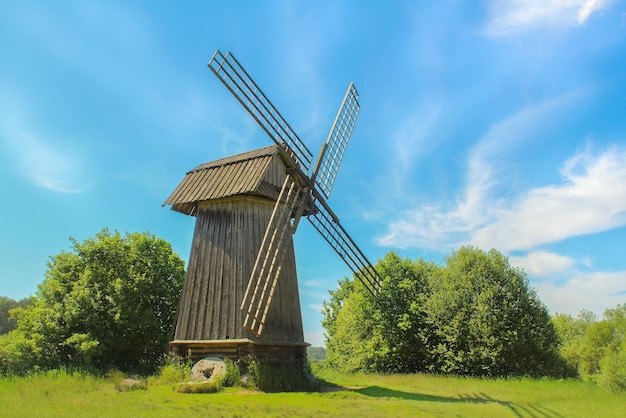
left=313, top=83, right=360, bottom=199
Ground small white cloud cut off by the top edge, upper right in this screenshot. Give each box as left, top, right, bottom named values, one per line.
left=487, top=0, right=611, bottom=36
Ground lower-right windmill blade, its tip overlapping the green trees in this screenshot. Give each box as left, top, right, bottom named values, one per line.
left=307, top=196, right=383, bottom=296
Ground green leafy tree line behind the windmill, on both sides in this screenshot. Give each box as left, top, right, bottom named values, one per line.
left=0, top=228, right=626, bottom=390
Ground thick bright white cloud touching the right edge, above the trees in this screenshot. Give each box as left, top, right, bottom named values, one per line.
left=471, top=147, right=626, bottom=251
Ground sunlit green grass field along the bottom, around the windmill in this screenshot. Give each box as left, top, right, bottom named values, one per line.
left=0, top=370, right=626, bottom=417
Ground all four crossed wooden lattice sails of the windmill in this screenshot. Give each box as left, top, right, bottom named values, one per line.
left=208, top=50, right=382, bottom=337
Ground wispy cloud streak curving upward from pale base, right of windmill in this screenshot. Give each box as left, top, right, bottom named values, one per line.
left=377, top=93, right=578, bottom=249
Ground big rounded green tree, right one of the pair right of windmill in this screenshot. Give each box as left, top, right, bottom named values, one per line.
left=425, top=247, right=562, bottom=376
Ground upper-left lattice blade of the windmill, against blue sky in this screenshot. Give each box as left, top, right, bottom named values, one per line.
left=208, top=50, right=313, bottom=173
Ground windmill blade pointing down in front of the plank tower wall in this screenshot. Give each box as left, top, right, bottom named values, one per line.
left=241, top=174, right=309, bottom=337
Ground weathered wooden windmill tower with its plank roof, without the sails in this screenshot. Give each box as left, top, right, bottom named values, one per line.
left=165, top=145, right=306, bottom=359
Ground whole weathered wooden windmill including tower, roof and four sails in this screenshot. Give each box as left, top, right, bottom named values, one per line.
left=164, top=50, right=381, bottom=363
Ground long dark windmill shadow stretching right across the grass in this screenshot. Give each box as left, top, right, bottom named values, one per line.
left=342, top=386, right=562, bottom=417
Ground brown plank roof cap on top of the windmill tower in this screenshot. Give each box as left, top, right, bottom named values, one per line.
left=163, top=145, right=286, bottom=215
